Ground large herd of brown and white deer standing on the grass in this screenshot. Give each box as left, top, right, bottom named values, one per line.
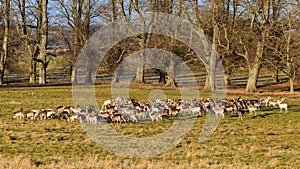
left=13, top=97, right=288, bottom=124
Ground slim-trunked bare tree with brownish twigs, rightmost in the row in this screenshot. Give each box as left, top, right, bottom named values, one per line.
left=266, top=1, right=300, bottom=93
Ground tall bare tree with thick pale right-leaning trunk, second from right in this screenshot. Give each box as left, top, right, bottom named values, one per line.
left=230, top=0, right=272, bottom=92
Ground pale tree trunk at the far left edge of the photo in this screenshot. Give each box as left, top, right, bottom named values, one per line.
left=0, top=0, right=11, bottom=85
